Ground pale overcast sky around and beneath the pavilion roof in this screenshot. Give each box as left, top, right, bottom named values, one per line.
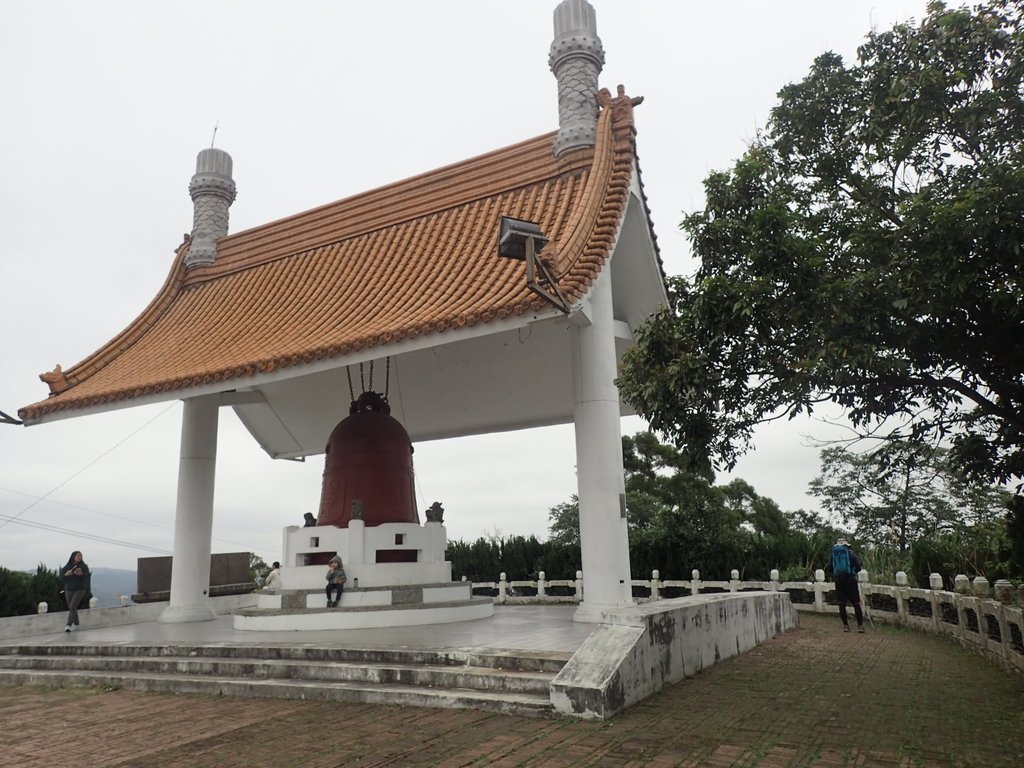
left=0, top=0, right=925, bottom=577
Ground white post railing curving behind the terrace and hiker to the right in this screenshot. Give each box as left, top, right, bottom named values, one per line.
left=463, top=569, right=1024, bottom=674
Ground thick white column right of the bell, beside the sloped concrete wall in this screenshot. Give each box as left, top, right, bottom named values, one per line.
left=571, top=267, right=633, bottom=622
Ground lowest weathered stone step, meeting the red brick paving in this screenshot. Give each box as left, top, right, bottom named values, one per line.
left=0, top=670, right=554, bottom=717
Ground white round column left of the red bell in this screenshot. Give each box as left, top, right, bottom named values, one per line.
left=160, top=395, right=218, bottom=624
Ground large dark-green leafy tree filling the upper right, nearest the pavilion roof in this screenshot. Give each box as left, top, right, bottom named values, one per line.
left=618, top=0, right=1024, bottom=481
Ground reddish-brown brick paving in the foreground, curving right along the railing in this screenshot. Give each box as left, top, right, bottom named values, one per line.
left=0, top=614, right=1024, bottom=768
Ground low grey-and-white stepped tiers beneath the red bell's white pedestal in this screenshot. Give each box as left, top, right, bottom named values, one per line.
left=233, top=581, right=495, bottom=631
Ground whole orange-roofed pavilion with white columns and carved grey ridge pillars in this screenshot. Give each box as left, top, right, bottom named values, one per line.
left=18, top=0, right=666, bottom=623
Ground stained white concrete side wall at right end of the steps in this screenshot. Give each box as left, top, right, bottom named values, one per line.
left=551, top=592, right=799, bottom=720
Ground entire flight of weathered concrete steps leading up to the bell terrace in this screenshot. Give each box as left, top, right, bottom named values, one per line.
left=0, top=644, right=569, bottom=717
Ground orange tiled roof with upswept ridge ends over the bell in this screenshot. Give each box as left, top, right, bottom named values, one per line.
left=18, top=103, right=635, bottom=422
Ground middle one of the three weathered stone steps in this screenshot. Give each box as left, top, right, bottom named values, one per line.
left=0, top=654, right=554, bottom=696
